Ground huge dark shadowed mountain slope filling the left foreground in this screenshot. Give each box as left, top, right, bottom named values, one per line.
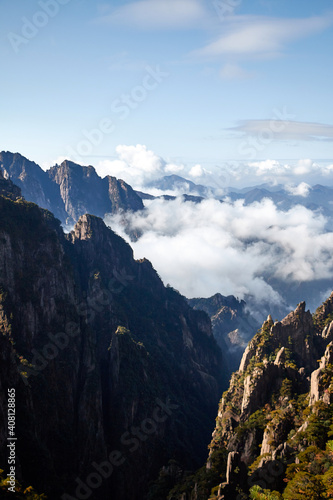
left=0, top=178, right=221, bottom=500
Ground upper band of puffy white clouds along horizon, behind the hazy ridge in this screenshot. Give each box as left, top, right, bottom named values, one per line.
left=96, top=144, right=333, bottom=192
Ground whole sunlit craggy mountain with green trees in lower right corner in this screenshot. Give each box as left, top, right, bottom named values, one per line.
left=164, top=293, right=333, bottom=500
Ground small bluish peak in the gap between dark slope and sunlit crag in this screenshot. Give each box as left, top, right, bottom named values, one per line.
left=188, top=293, right=259, bottom=384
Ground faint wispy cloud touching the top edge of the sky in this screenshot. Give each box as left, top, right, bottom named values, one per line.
left=99, top=0, right=207, bottom=30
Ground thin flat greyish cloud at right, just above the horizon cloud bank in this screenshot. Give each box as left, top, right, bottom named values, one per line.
left=231, top=120, right=333, bottom=141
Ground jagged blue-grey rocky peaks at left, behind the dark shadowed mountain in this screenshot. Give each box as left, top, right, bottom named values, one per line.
left=0, top=152, right=143, bottom=225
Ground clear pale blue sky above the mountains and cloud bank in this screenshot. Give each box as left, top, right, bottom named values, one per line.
left=0, top=0, right=333, bottom=173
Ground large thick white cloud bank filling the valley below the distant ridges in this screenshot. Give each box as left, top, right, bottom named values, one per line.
left=107, top=199, right=333, bottom=304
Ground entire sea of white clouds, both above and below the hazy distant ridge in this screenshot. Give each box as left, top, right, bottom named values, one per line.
left=93, top=145, right=333, bottom=316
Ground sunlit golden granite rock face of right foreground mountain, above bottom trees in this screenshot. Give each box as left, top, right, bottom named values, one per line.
left=200, top=294, right=333, bottom=500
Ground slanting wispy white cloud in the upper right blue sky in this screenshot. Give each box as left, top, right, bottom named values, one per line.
left=192, top=16, right=333, bottom=58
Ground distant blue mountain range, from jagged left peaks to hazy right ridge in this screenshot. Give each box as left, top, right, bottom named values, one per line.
left=0, top=151, right=333, bottom=228
